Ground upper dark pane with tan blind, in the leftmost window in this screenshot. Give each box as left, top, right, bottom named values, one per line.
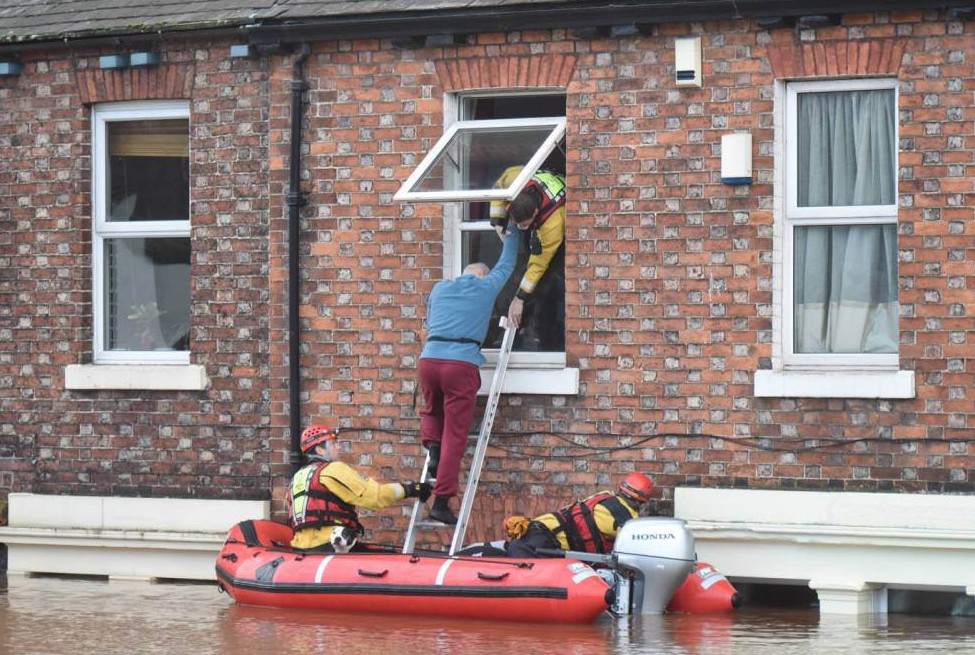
left=106, top=120, right=190, bottom=222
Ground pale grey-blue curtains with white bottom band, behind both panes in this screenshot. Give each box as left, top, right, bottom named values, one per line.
left=794, top=90, right=898, bottom=353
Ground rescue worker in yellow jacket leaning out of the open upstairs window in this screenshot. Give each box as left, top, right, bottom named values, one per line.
left=491, top=166, right=566, bottom=351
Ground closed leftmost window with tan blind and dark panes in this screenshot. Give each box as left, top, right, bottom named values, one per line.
left=92, top=102, right=190, bottom=364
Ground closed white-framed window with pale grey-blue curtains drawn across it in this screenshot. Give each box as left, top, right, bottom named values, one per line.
left=756, top=79, right=913, bottom=396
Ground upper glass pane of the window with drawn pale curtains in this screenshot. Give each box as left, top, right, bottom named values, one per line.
left=796, top=89, right=897, bottom=207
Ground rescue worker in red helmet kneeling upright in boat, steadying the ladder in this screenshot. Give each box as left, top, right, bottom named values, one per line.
left=288, top=425, right=431, bottom=552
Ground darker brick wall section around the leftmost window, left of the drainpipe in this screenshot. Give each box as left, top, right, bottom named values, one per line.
left=0, top=43, right=270, bottom=498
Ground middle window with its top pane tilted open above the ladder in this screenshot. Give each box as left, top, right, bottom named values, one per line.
left=396, top=94, right=565, bottom=367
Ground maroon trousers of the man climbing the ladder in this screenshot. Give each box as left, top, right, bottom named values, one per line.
left=419, top=359, right=481, bottom=496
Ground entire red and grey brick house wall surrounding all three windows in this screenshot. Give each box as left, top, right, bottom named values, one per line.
left=0, top=11, right=975, bottom=539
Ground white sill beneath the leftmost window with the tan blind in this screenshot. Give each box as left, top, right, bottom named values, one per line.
left=64, top=364, right=210, bottom=391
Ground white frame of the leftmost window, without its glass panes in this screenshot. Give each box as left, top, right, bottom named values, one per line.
left=91, top=100, right=191, bottom=364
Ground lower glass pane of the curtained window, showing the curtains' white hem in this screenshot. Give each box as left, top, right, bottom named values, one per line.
left=793, top=224, right=898, bottom=353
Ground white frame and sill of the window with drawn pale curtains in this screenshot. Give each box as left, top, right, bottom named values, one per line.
left=755, top=78, right=914, bottom=398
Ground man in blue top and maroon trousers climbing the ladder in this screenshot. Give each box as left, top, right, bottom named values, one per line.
left=419, top=221, right=519, bottom=525
